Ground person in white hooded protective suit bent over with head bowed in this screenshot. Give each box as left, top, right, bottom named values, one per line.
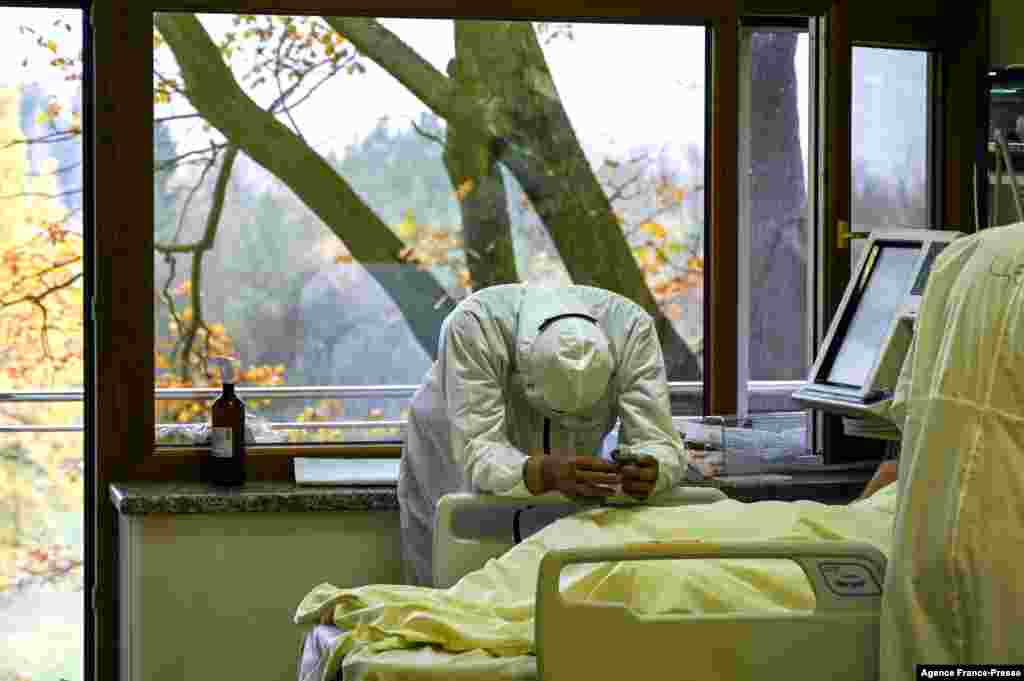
left=398, top=284, right=685, bottom=586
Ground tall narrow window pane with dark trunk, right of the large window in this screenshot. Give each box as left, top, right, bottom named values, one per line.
left=737, top=28, right=811, bottom=424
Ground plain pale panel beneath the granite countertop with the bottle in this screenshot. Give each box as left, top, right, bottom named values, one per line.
left=120, top=511, right=401, bottom=681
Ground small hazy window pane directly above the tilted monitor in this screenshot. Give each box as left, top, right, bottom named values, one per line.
left=850, top=46, right=933, bottom=265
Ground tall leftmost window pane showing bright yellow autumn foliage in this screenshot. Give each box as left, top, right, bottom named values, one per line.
left=0, top=7, right=85, bottom=681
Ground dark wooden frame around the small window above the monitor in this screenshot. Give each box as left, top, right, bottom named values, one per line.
left=814, top=0, right=990, bottom=463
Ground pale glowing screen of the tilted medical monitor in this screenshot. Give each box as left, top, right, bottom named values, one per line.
left=827, top=245, right=921, bottom=388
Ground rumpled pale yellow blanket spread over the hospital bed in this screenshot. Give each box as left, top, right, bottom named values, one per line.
left=295, top=484, right=897, bottom=671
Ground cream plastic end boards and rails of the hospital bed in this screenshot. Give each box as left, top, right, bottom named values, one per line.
left=434, top=487, right=886, bottom=681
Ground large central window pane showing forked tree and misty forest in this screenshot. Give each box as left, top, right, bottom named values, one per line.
left=153, top=13, right=708, bottom=443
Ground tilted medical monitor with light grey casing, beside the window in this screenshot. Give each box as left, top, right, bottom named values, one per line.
left=793, top=229, right=963, bottom=440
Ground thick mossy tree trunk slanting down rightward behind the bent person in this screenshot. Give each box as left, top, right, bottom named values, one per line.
left=448, top=22, right=700, bottom=380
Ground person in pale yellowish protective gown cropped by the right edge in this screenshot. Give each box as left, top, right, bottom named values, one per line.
left=881, top=223, right=1024, bottom=681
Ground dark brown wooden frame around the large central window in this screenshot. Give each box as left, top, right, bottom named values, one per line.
left=93, top=0, right=843, bottom=489
